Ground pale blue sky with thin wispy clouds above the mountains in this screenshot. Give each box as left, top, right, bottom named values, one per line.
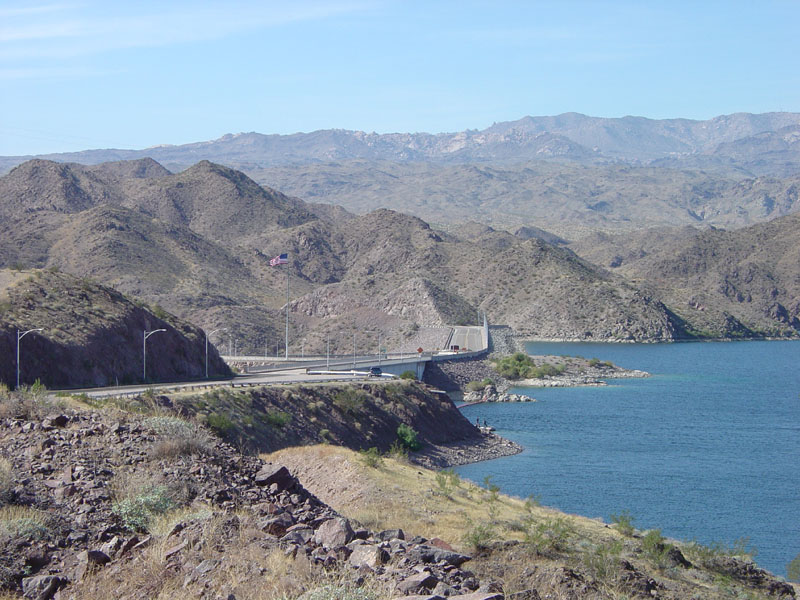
left=0, top=0, right=800, bottom=155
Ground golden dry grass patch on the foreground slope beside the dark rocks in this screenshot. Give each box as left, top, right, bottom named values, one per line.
left=262, top=445, right=617, bottom=550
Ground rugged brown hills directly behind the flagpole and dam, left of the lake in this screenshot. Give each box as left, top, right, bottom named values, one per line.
left=0, top=161, right=700, bottom=354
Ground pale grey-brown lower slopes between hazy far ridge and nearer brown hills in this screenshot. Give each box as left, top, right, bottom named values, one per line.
left=255, top=160, right=800, bottom=240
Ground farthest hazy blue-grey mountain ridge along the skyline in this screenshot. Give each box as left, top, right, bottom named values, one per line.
left=6, top=113, right=800, bottom=176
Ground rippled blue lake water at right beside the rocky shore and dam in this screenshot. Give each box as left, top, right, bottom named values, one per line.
left=457, top=341, right=800, bottom=576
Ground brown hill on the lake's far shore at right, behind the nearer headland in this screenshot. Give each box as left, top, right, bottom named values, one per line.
left=572, top=215, right=800, bottom=337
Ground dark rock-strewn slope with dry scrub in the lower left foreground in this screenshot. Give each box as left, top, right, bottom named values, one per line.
left=0, top=390, right=502, bottom=600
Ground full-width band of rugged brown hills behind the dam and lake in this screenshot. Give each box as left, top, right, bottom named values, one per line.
left=0, top=158, right=800, bottom=344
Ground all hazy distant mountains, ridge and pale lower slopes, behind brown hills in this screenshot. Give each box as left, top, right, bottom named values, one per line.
left=0, top=113, right=800, bottom=240
